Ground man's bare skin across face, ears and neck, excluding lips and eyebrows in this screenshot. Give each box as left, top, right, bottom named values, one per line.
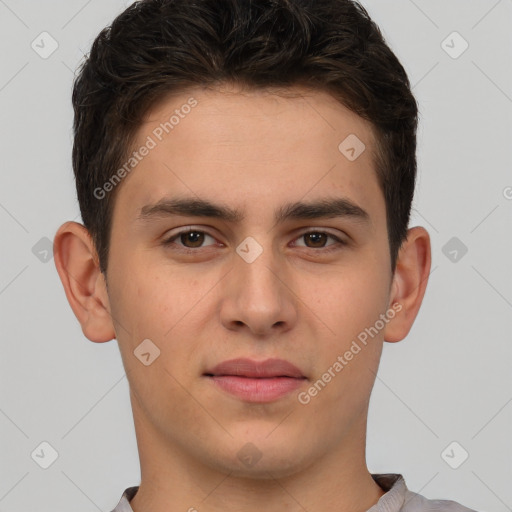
left=54, top=85, right=431, bottom=512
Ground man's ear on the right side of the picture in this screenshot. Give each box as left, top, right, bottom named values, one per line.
left=384, top=227, right=431, bottom=343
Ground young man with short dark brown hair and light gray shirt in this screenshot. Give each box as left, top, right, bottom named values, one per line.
left=55, top=0, right=476, bottom=512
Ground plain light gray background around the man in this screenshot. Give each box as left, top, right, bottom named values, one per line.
left=0, top=0, right=512, bottom=512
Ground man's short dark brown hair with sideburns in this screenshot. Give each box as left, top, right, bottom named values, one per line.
left=72, top=0, right=418, bottom=272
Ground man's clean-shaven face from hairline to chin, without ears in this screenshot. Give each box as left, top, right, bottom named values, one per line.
left=103, top=88, right=392, bottom=477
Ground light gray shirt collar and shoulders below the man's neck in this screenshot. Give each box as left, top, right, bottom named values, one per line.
left=112, top=473, right=475, bottom=512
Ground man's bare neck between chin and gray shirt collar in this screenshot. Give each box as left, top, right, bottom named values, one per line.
left=130, top=404, right=385, bottom=512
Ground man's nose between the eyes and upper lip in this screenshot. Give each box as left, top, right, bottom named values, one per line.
left=220, top=239, right=299, bottom=337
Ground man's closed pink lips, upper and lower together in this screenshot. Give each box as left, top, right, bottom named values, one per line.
left=204, top=358, right=306, bottom=403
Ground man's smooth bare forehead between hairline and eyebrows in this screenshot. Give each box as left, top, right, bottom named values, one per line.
left=114, top=87, right=384, bottom=225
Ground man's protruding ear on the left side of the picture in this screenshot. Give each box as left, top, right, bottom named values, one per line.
left=53, top=222, right=115, bottom=343
